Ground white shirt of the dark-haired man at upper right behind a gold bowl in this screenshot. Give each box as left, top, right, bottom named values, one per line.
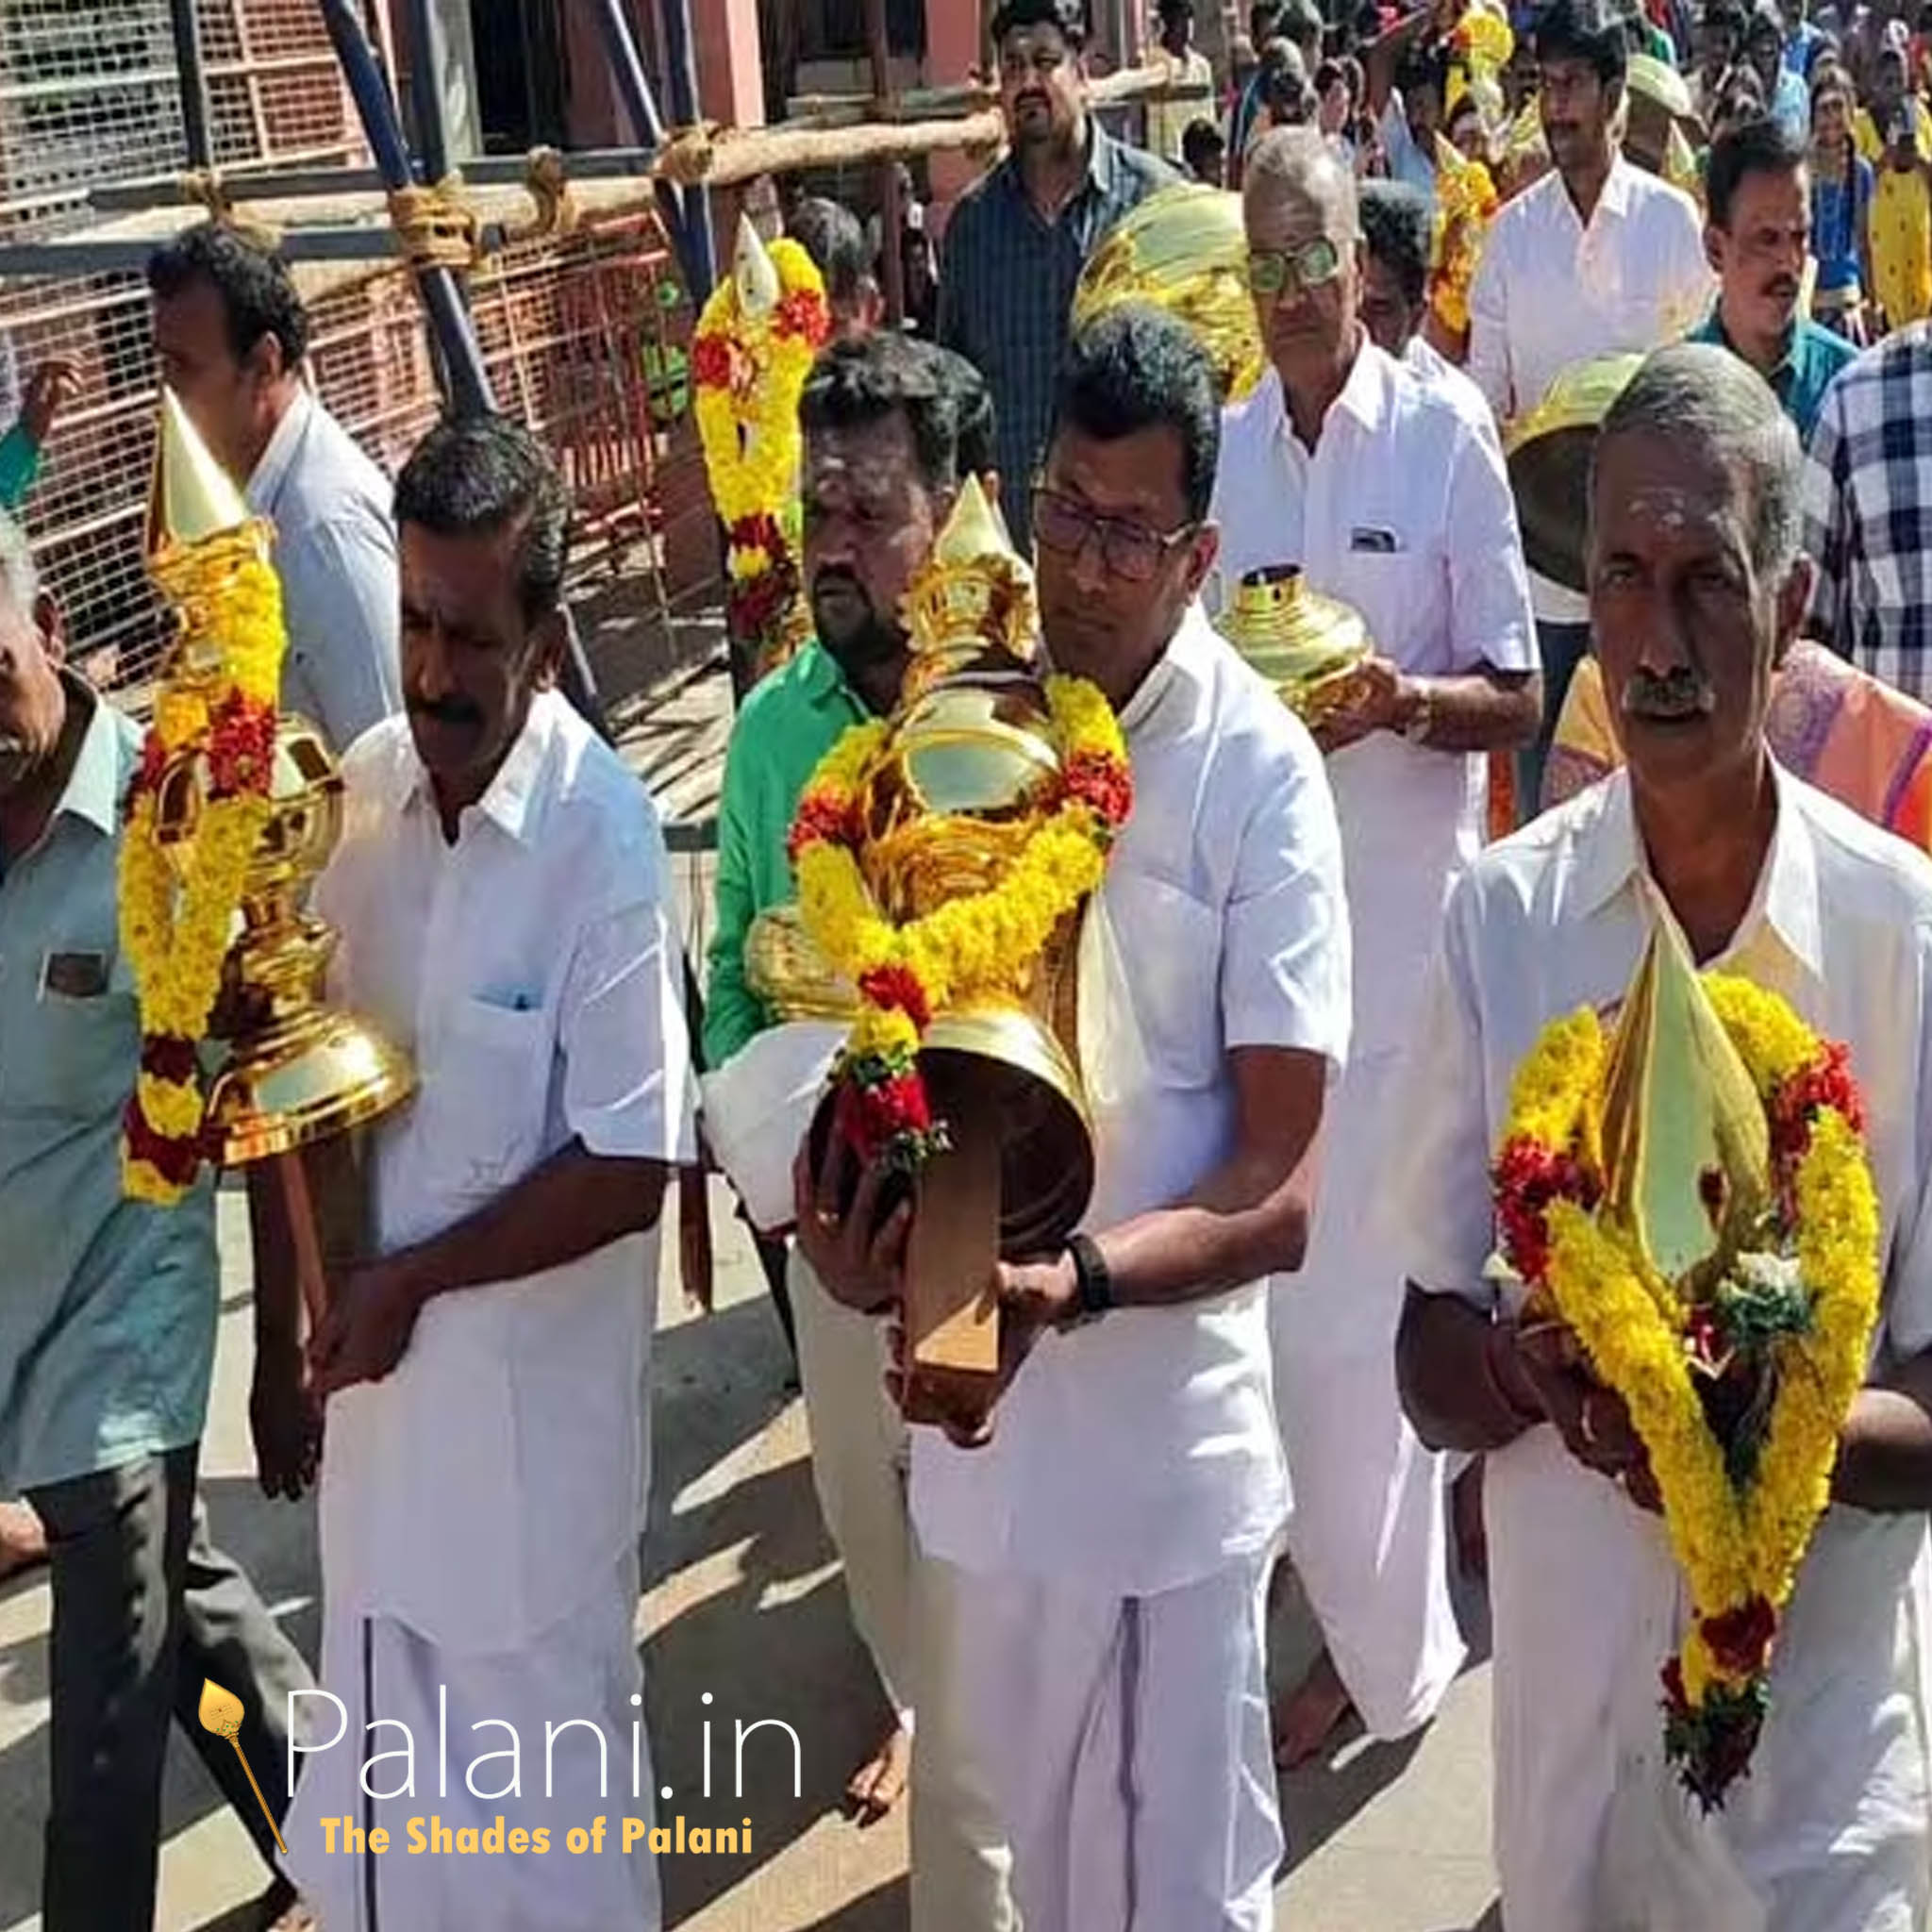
left=1468, top=155, right=1718, bottom=625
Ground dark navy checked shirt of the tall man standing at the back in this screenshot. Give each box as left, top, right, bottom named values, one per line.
left=939, top=116, right=1178, bottom=549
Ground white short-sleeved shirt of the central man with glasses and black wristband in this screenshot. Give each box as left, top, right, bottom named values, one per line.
left=912, top=608, right=1349, bottom=1596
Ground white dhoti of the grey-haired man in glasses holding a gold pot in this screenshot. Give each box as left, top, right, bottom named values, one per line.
left=1270, top=1053, right=1464, bottom=1737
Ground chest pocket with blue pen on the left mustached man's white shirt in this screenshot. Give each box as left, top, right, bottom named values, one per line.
left=415, top=997, right=551, bottom=1196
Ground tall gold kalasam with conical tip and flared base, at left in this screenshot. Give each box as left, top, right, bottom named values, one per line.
left=149, top=391, right=413, bottom=1167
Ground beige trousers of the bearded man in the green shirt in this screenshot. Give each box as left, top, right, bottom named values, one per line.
left=787, top=1246, right=1018, bottom=1932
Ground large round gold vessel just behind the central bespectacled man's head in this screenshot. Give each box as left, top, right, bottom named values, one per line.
left=1073, top=182, right=1265, bottom=402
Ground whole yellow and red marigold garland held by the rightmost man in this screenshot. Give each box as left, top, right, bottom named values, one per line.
left=1493, top=974, right=1880, bottom=1810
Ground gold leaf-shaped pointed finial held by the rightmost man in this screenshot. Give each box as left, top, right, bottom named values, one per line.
left=1600, top=907, right=1772, bottom=1298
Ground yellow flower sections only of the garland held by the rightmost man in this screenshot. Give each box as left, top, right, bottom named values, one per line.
left=1503, top=974, right=1882, bottom=1709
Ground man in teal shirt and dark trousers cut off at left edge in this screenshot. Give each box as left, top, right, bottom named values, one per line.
left=0, top=516, right=311, bottom=1932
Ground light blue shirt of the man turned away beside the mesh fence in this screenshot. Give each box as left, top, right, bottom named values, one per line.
left=247, top=391, right=402, bottom=752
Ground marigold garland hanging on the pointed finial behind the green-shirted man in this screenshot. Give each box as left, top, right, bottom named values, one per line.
left=691, top=240, right=831, bottom=673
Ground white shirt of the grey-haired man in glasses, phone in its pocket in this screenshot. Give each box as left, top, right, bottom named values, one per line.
left=1213, top=341, right=1536, bottom=1058
